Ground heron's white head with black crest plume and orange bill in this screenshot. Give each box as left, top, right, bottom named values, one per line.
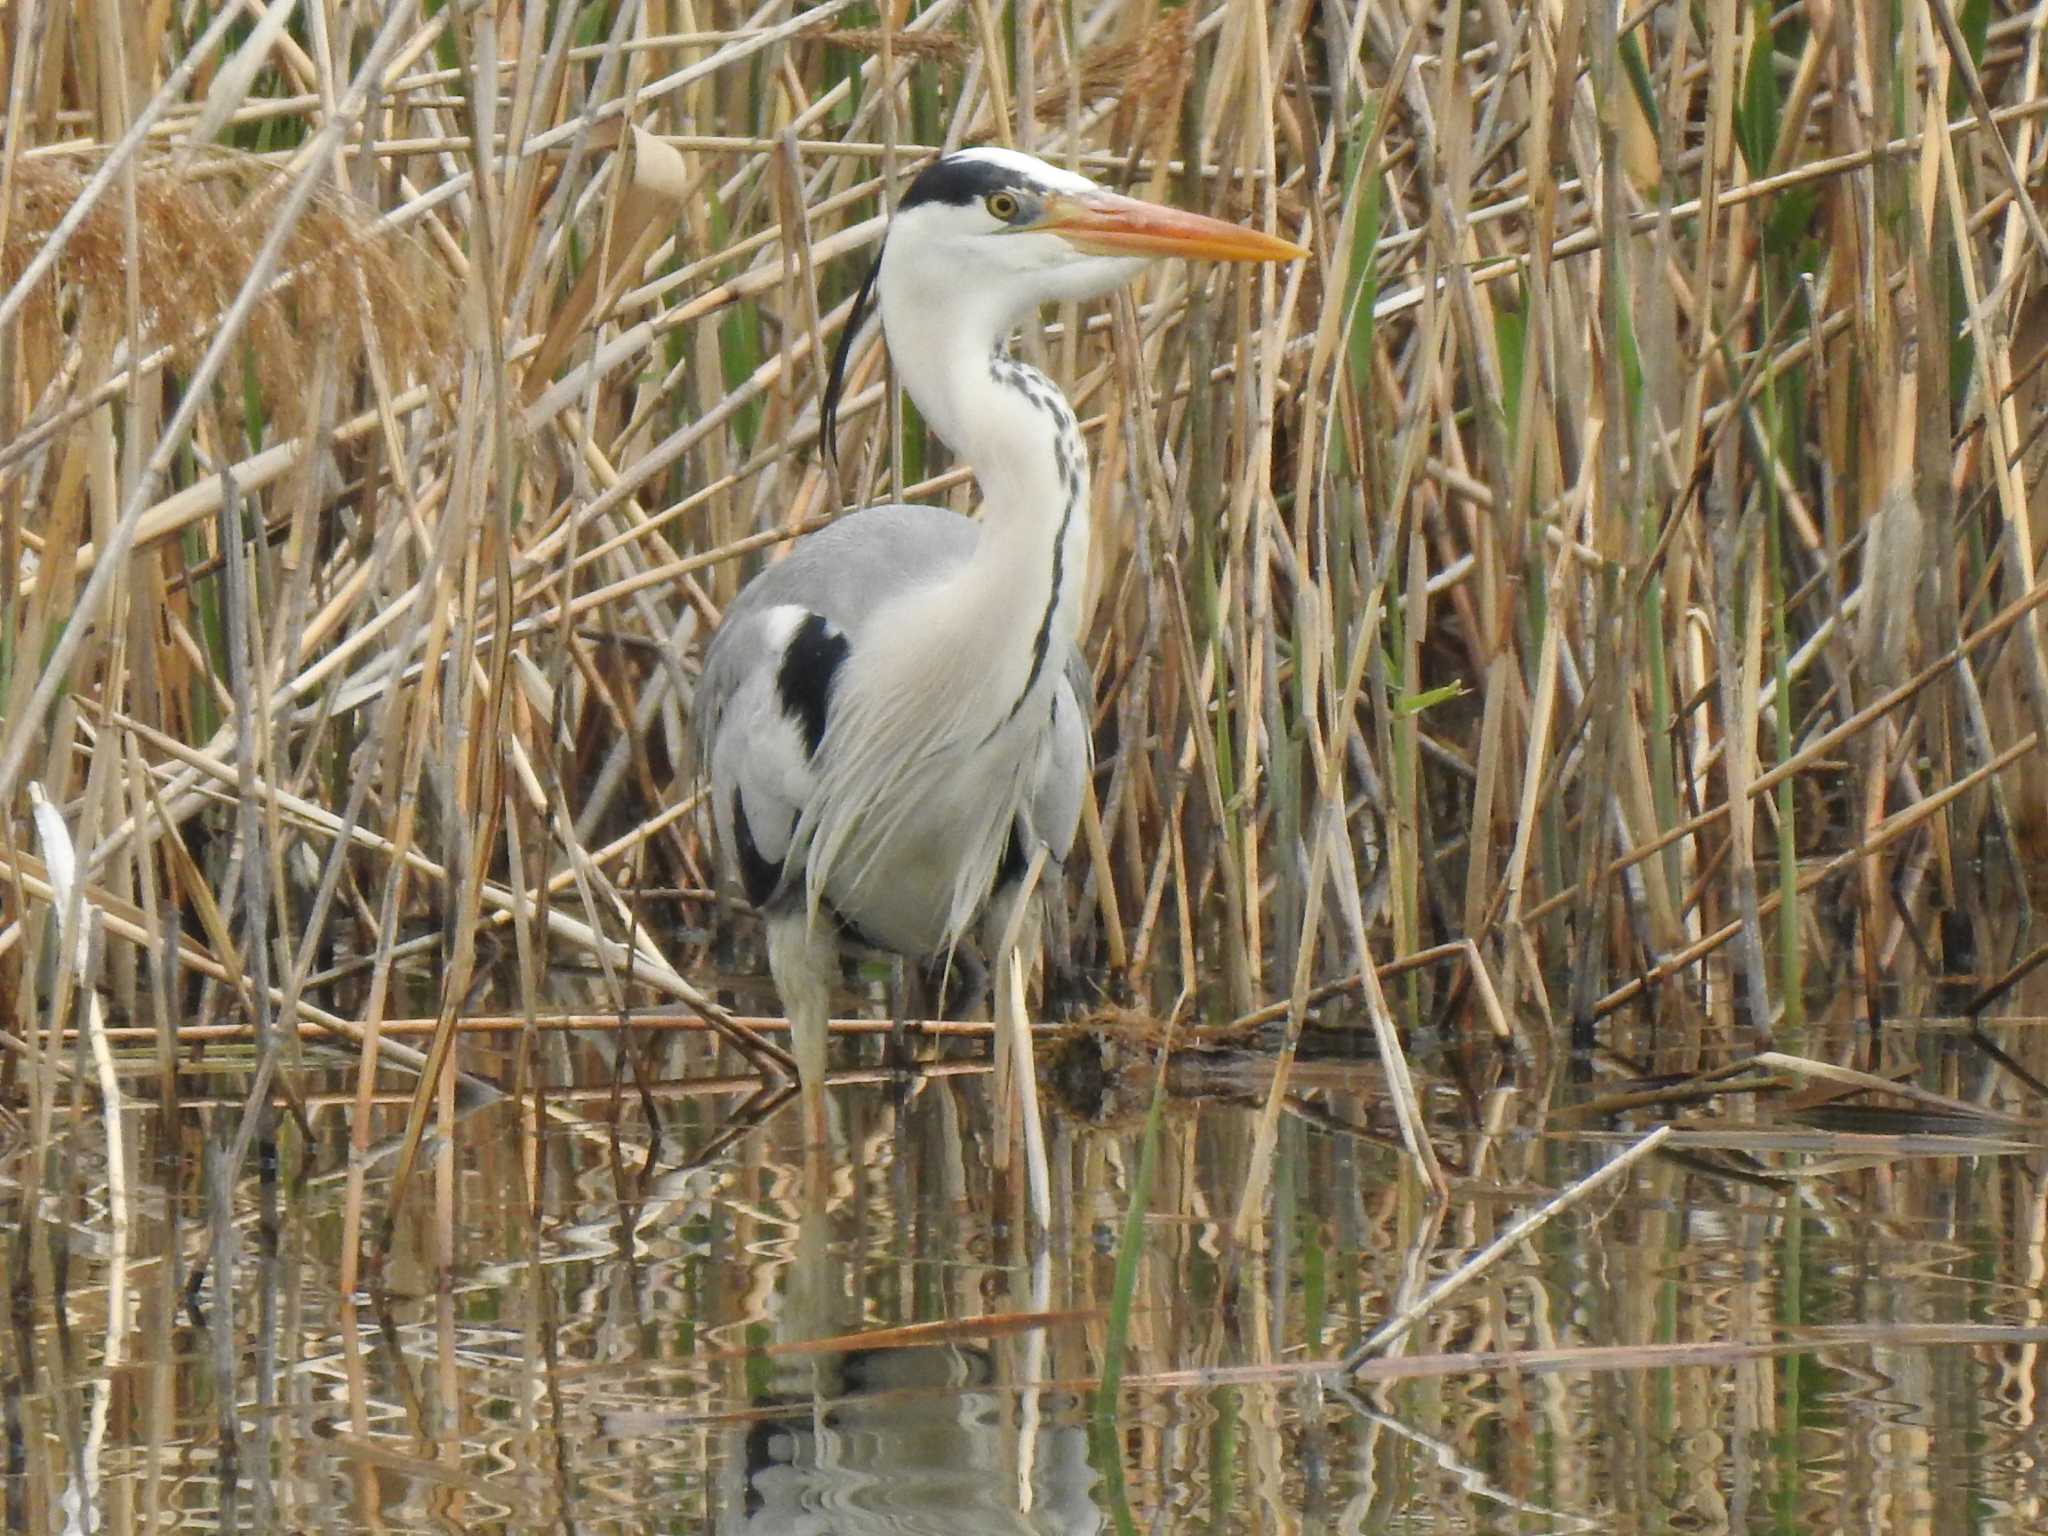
left=821, top=145, right=1307, bottom=453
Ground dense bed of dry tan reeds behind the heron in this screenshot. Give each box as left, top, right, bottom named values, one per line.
left=0, top=0, right=2048, bottom=1179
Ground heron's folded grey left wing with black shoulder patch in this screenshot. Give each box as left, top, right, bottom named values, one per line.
left=694, top=506, right=983, bottom=905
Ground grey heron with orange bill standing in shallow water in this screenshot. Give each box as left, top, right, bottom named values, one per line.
left=696, top=147, right=1307, bottom=1145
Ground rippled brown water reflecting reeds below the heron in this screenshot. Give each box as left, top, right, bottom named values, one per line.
left=0, top=1003, right=2048, bottom=1534
